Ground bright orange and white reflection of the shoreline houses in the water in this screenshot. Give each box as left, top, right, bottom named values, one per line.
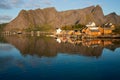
left=56, top=37, right=114, bottom=47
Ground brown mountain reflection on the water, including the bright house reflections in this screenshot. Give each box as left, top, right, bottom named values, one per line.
left=0, top=36, right=120, bottom=57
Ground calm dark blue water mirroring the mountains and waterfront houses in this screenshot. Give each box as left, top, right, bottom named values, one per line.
left=0, top=36, right=120, bottom=80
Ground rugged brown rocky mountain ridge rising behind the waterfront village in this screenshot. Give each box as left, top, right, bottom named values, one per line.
left=4, top=5, right=120, bottom=31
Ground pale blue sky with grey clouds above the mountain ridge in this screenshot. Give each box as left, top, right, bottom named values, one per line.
left=0, top=0, right=120, bottom=23
